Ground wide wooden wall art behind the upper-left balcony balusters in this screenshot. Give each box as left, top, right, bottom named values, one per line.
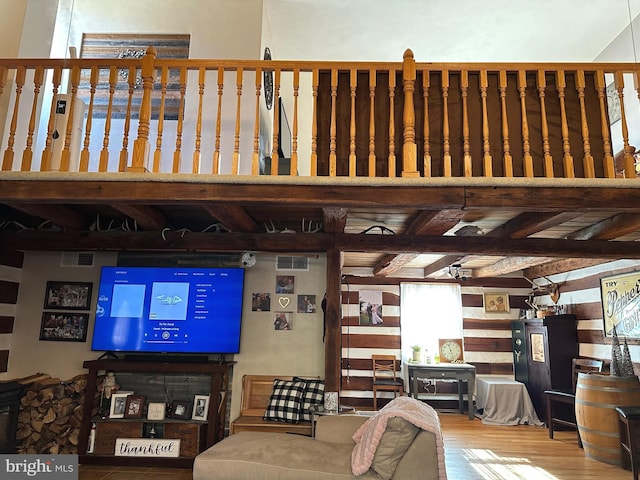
left=78, top=33, right=191, bottom=120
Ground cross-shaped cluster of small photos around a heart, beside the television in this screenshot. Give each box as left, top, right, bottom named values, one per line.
left=251, top=275, right=318, bottom=331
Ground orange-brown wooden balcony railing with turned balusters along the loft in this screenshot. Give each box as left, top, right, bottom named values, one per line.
left=0, top=47, right=640, bottom=178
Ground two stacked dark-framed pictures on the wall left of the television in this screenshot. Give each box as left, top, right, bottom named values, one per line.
left=40, top=281, right=93, bottom=342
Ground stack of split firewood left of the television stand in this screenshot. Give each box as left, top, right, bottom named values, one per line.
left=16, top=374, right=87, bottom=454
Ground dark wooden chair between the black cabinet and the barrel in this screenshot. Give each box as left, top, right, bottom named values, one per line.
left=544, top=358, right=604, bottom=448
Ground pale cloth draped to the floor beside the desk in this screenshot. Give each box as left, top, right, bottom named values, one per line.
left=476, top=375, right=544, bottom=426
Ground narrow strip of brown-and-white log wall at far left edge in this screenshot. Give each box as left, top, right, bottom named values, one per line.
left=0, top=249, right=24, bottom=372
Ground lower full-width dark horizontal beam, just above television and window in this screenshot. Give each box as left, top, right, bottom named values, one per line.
left=0, top=230, right=640, bottom=259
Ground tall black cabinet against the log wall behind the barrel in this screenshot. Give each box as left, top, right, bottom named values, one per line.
left=511, top=315, right=578, bottom=419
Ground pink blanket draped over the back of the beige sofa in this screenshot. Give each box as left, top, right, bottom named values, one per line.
left=351, top=397, right=447, bottom=480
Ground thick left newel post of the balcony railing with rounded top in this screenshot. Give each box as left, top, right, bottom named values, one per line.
left=127, top=46, right=157, bottom=173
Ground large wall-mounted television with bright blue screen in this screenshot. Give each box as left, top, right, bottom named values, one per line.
left=91, top=267, right=244, bottom=354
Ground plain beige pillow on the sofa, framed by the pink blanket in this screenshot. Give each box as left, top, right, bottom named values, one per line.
left=371, top=417, right=420, bottom=480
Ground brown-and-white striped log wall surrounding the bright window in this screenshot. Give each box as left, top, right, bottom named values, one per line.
left=340, top=277, right=531, bottom=408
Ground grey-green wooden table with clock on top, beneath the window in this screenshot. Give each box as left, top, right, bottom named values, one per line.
left=407, top=363, right=476, bottom=420
